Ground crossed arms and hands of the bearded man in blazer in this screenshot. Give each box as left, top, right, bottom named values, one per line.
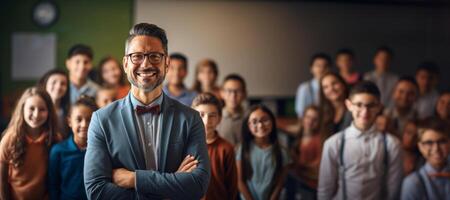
left=84, top=113, right=211, bottom=199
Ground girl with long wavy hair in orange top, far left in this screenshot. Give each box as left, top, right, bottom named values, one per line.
left=0, top=87, right=61, bottom=199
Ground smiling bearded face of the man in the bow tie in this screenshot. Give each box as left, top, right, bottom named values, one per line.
left=123, top=36, right=169, bottom=92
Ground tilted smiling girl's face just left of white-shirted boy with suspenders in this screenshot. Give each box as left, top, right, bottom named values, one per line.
left=321, top=75, right=345, bottom=102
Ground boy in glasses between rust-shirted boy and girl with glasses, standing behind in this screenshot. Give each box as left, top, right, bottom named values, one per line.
left=217, top=74, right=247, bottom=146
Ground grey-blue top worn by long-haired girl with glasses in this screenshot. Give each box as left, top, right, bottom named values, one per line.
left=236, top=142, right=289, bottom=200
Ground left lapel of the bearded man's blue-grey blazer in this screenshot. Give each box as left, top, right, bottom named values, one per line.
left=120, top=93, right=145, bottom=169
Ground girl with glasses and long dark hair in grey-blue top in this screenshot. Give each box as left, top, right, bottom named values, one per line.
left=236, top=105, right=289, bottom=200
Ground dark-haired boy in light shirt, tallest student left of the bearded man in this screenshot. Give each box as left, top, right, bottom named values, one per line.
left=66, top=44, right=99, bottom=104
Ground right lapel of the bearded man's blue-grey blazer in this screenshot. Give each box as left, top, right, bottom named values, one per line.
left=158, top=93, right=174, bottom=172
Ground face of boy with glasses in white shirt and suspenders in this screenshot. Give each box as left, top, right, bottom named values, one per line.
left=345, top=93, right=381, bottom=129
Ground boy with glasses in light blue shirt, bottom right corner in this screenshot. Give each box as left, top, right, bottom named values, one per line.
left=401, top=120, right=450, bottom=200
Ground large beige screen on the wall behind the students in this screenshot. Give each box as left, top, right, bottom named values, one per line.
left=134, top=0, right=450, bottom=97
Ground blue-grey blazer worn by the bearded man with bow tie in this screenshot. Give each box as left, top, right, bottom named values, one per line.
left=84, top=94, right=211, bottom=199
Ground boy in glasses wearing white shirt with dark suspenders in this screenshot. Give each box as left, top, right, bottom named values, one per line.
left=317, top=81, right=403, bottom=200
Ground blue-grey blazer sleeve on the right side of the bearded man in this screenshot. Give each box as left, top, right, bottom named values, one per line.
left=136, top=112, right=211, bottom=199
